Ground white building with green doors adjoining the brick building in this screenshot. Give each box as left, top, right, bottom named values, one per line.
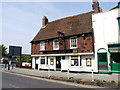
left=92, top=3, right=120, bottom=72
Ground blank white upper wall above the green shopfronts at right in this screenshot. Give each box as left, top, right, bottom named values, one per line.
left=92, top=9, right=120, bottom=47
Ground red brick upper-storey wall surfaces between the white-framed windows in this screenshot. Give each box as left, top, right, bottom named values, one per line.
left=31, top=36, right=93, bottom=54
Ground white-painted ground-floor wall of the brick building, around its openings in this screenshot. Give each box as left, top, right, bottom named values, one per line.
left=32, top=53, right=98, bottom=72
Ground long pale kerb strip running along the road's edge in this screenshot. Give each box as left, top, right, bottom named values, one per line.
left=2, top=71, right=105, bottom=88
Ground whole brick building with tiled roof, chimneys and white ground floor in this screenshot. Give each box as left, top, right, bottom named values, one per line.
left=31, top=0, right=101, bottom=72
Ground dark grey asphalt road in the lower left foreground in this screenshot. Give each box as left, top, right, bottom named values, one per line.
left=2, top=72, right=93, bottom=90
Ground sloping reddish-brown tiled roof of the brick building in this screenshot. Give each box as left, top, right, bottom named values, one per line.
left=31, top=11, right=94, bottom=42
